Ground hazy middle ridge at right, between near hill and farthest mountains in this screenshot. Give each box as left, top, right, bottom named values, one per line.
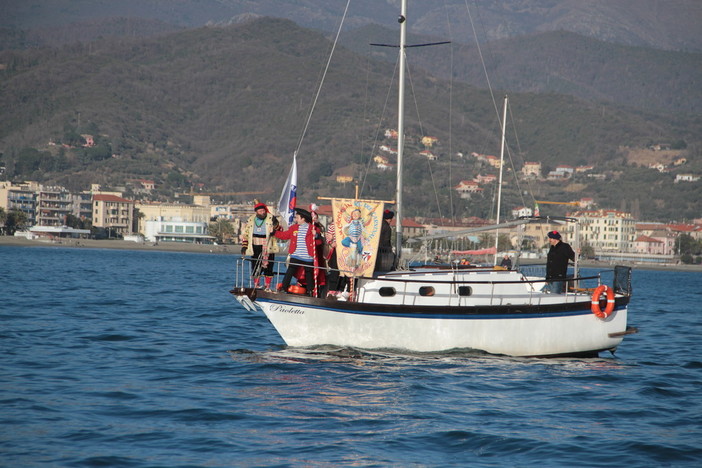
left=344, top=26, right=702, bottom=114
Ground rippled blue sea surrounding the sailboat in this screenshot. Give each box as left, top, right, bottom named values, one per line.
left=0, top=246, right=702, bottom=467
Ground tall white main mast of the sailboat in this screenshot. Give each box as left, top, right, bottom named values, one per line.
left=395, top=0, right=407, bottom=265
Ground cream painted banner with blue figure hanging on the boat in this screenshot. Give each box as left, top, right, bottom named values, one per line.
left=332, top=199, right=384, bottom=277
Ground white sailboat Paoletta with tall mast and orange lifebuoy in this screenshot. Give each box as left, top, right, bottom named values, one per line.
left=231, top=0, right=634, bottom=356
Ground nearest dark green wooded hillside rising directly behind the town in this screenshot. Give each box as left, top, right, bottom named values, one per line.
left=0, top=18, right=702, bottom=222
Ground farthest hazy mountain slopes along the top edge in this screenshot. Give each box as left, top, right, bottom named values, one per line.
left=0, top=0, right=702, bottom=52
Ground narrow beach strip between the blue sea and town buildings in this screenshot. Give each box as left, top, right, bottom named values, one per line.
left=0, top=236, right=702, bottom=272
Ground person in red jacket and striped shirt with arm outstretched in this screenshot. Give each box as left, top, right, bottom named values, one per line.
left=275, top=208, right=322, bottom=296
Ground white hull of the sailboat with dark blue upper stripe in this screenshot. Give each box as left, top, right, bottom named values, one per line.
left=246, top=292, right=628, bottom=356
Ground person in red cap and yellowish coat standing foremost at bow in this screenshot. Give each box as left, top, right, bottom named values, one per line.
left=241, top=201, right=280, bottom=290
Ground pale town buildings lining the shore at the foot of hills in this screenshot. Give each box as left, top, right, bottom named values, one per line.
left=0, top=178, right=702, bottom=262
